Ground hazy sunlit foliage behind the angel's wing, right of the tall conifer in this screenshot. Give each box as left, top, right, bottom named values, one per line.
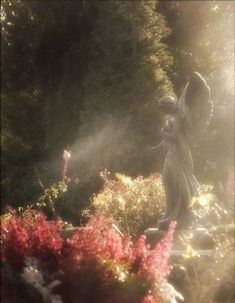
left=157, top=1, right=234, bottom=189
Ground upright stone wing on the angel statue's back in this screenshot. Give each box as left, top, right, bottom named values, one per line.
left=178, top=72, right=213, bottom=146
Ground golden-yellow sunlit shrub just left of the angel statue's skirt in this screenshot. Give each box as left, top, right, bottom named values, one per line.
left=84, top=171, right=165, bottom=236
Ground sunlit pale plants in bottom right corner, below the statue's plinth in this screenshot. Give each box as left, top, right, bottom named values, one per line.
left=169, top=227, right=235, bottom=303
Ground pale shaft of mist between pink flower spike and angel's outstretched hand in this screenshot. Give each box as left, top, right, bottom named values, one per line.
left=71, top=118, right=134, bottom=181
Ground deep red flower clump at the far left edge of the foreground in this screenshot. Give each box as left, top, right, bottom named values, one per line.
left=1, top=210, right=63, bottom=269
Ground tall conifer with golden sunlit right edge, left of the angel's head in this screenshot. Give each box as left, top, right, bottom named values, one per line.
left=79, top=1, right=173, bottom=175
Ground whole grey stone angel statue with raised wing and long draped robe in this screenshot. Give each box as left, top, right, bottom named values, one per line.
left=153, top=72, right=213, bottom=229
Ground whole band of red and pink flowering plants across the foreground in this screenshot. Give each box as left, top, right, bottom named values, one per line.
left=1, top=211, right=180, bottom=303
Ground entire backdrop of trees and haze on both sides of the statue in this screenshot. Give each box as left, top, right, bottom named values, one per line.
left=1, top=0, right=234, bottom=209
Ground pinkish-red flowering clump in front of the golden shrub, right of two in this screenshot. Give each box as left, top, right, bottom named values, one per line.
left=58, top=215, right=175, bottom=303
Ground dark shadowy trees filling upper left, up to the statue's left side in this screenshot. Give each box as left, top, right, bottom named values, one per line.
left=1, top=0, right=173, bottom=208
